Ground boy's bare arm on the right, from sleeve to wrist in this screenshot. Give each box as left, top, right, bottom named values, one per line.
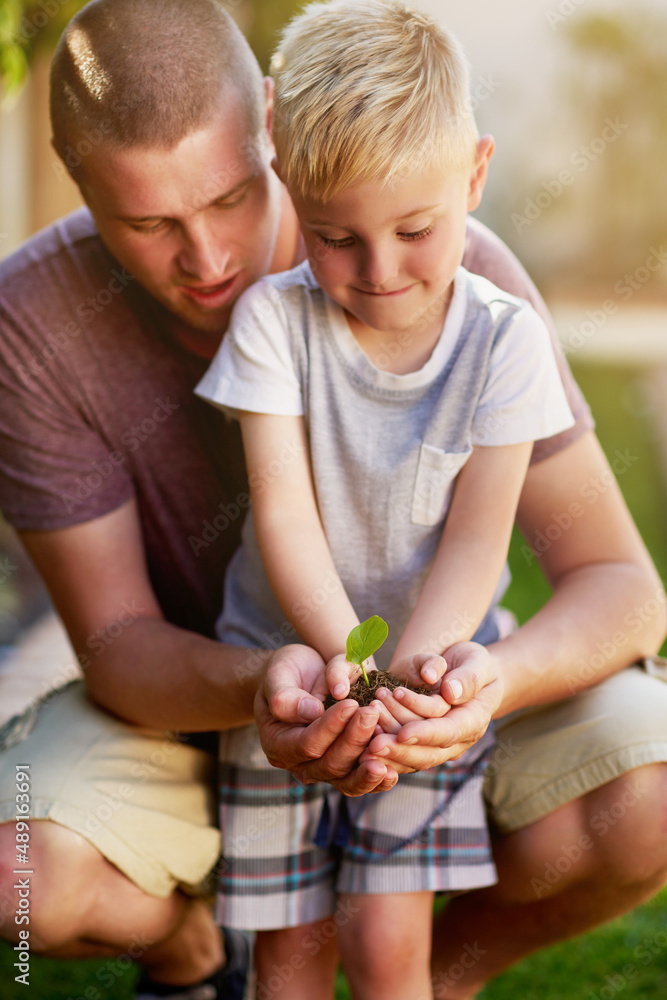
left=391, top=442, right=532, bottom=669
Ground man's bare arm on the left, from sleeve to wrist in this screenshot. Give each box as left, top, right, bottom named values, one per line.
left=21, top=500, right=268, bottom=732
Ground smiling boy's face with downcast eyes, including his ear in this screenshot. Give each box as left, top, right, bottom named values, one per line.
left=290, top=140, right=493, bottom=348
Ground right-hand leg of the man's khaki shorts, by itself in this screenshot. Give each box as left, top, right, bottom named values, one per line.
left=484, top=658, right=667, bottom=832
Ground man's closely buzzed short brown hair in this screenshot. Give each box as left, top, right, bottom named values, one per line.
left=51, top=0, right=265, bottom=168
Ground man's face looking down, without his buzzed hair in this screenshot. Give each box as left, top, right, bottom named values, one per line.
left=81, top=98, right=282, bottom=345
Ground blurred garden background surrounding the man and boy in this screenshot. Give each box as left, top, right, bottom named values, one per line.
left=0, top=0, right=667, bottom=1000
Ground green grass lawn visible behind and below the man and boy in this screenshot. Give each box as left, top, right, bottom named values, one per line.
left=0, top=366, right=667, bottom=1000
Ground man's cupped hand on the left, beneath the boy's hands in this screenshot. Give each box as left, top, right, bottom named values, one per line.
left=255, top=645, right=398, bottom=795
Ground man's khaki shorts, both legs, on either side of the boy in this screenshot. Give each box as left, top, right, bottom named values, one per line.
left=0, top=667, right=667, bottom=897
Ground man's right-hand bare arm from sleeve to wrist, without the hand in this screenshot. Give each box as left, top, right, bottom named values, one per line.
left=493, top=432, right=667, bottom=714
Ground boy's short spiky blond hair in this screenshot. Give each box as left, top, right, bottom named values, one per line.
left=271, top=0, right=478, bottom=201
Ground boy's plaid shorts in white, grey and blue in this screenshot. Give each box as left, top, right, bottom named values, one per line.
left=217, top=726, right=496, bottom=930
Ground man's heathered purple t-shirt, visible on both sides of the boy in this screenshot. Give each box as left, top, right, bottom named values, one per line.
left=0, top=209, right=592, bottom=635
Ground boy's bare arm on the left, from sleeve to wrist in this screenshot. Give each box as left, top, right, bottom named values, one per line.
left=239, top=411, right=359, bottom=660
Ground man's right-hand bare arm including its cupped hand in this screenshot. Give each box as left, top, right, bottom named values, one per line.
left=370, top=432, right=667, bottom=771
